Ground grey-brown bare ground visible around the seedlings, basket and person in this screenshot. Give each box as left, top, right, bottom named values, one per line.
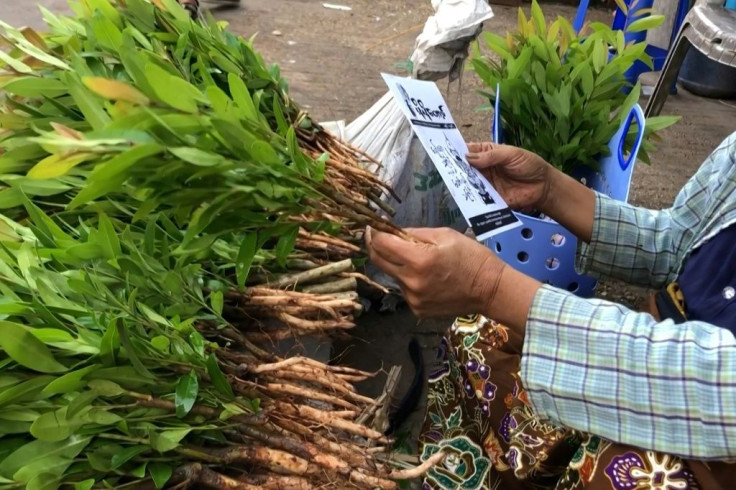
left=5, top=0, right=736, bottom=444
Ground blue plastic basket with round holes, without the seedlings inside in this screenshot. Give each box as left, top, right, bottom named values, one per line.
left=485, top=87, right=645, bottom=297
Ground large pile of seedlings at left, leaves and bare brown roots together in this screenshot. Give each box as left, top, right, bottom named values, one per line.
left=0, top=0, right=442, bottom=489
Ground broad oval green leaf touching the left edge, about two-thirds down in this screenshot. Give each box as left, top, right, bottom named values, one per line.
left=0, top=321, right=67, bottom=373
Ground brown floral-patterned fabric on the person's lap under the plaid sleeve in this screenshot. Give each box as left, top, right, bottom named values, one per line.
left=420, top=316, right=736, bottom=490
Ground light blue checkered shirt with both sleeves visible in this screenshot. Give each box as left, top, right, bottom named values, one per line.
left=521, top=133, right=736, bottom=460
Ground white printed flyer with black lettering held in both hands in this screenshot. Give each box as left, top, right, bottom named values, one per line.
left=383, top=74, right=521, bottom=241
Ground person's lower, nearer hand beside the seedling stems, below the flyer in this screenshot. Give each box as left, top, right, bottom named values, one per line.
left=366, top=228, right=506, bottom=318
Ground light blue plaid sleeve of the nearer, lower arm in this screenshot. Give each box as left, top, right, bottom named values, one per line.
left=521, top=286, right=736, bottom=460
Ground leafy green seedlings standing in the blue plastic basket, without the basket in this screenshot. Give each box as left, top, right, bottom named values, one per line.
left=472, top=1, right=679, bottom=173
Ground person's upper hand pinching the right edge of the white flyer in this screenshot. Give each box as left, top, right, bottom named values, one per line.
left=467, top=143, right=554, bottom=211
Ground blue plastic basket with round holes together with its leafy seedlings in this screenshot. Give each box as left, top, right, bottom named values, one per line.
left=472, top=1, right=679, bottom=296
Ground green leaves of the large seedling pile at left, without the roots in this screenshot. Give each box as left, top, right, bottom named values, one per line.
left=0, top=0, right=374, bottom=490
